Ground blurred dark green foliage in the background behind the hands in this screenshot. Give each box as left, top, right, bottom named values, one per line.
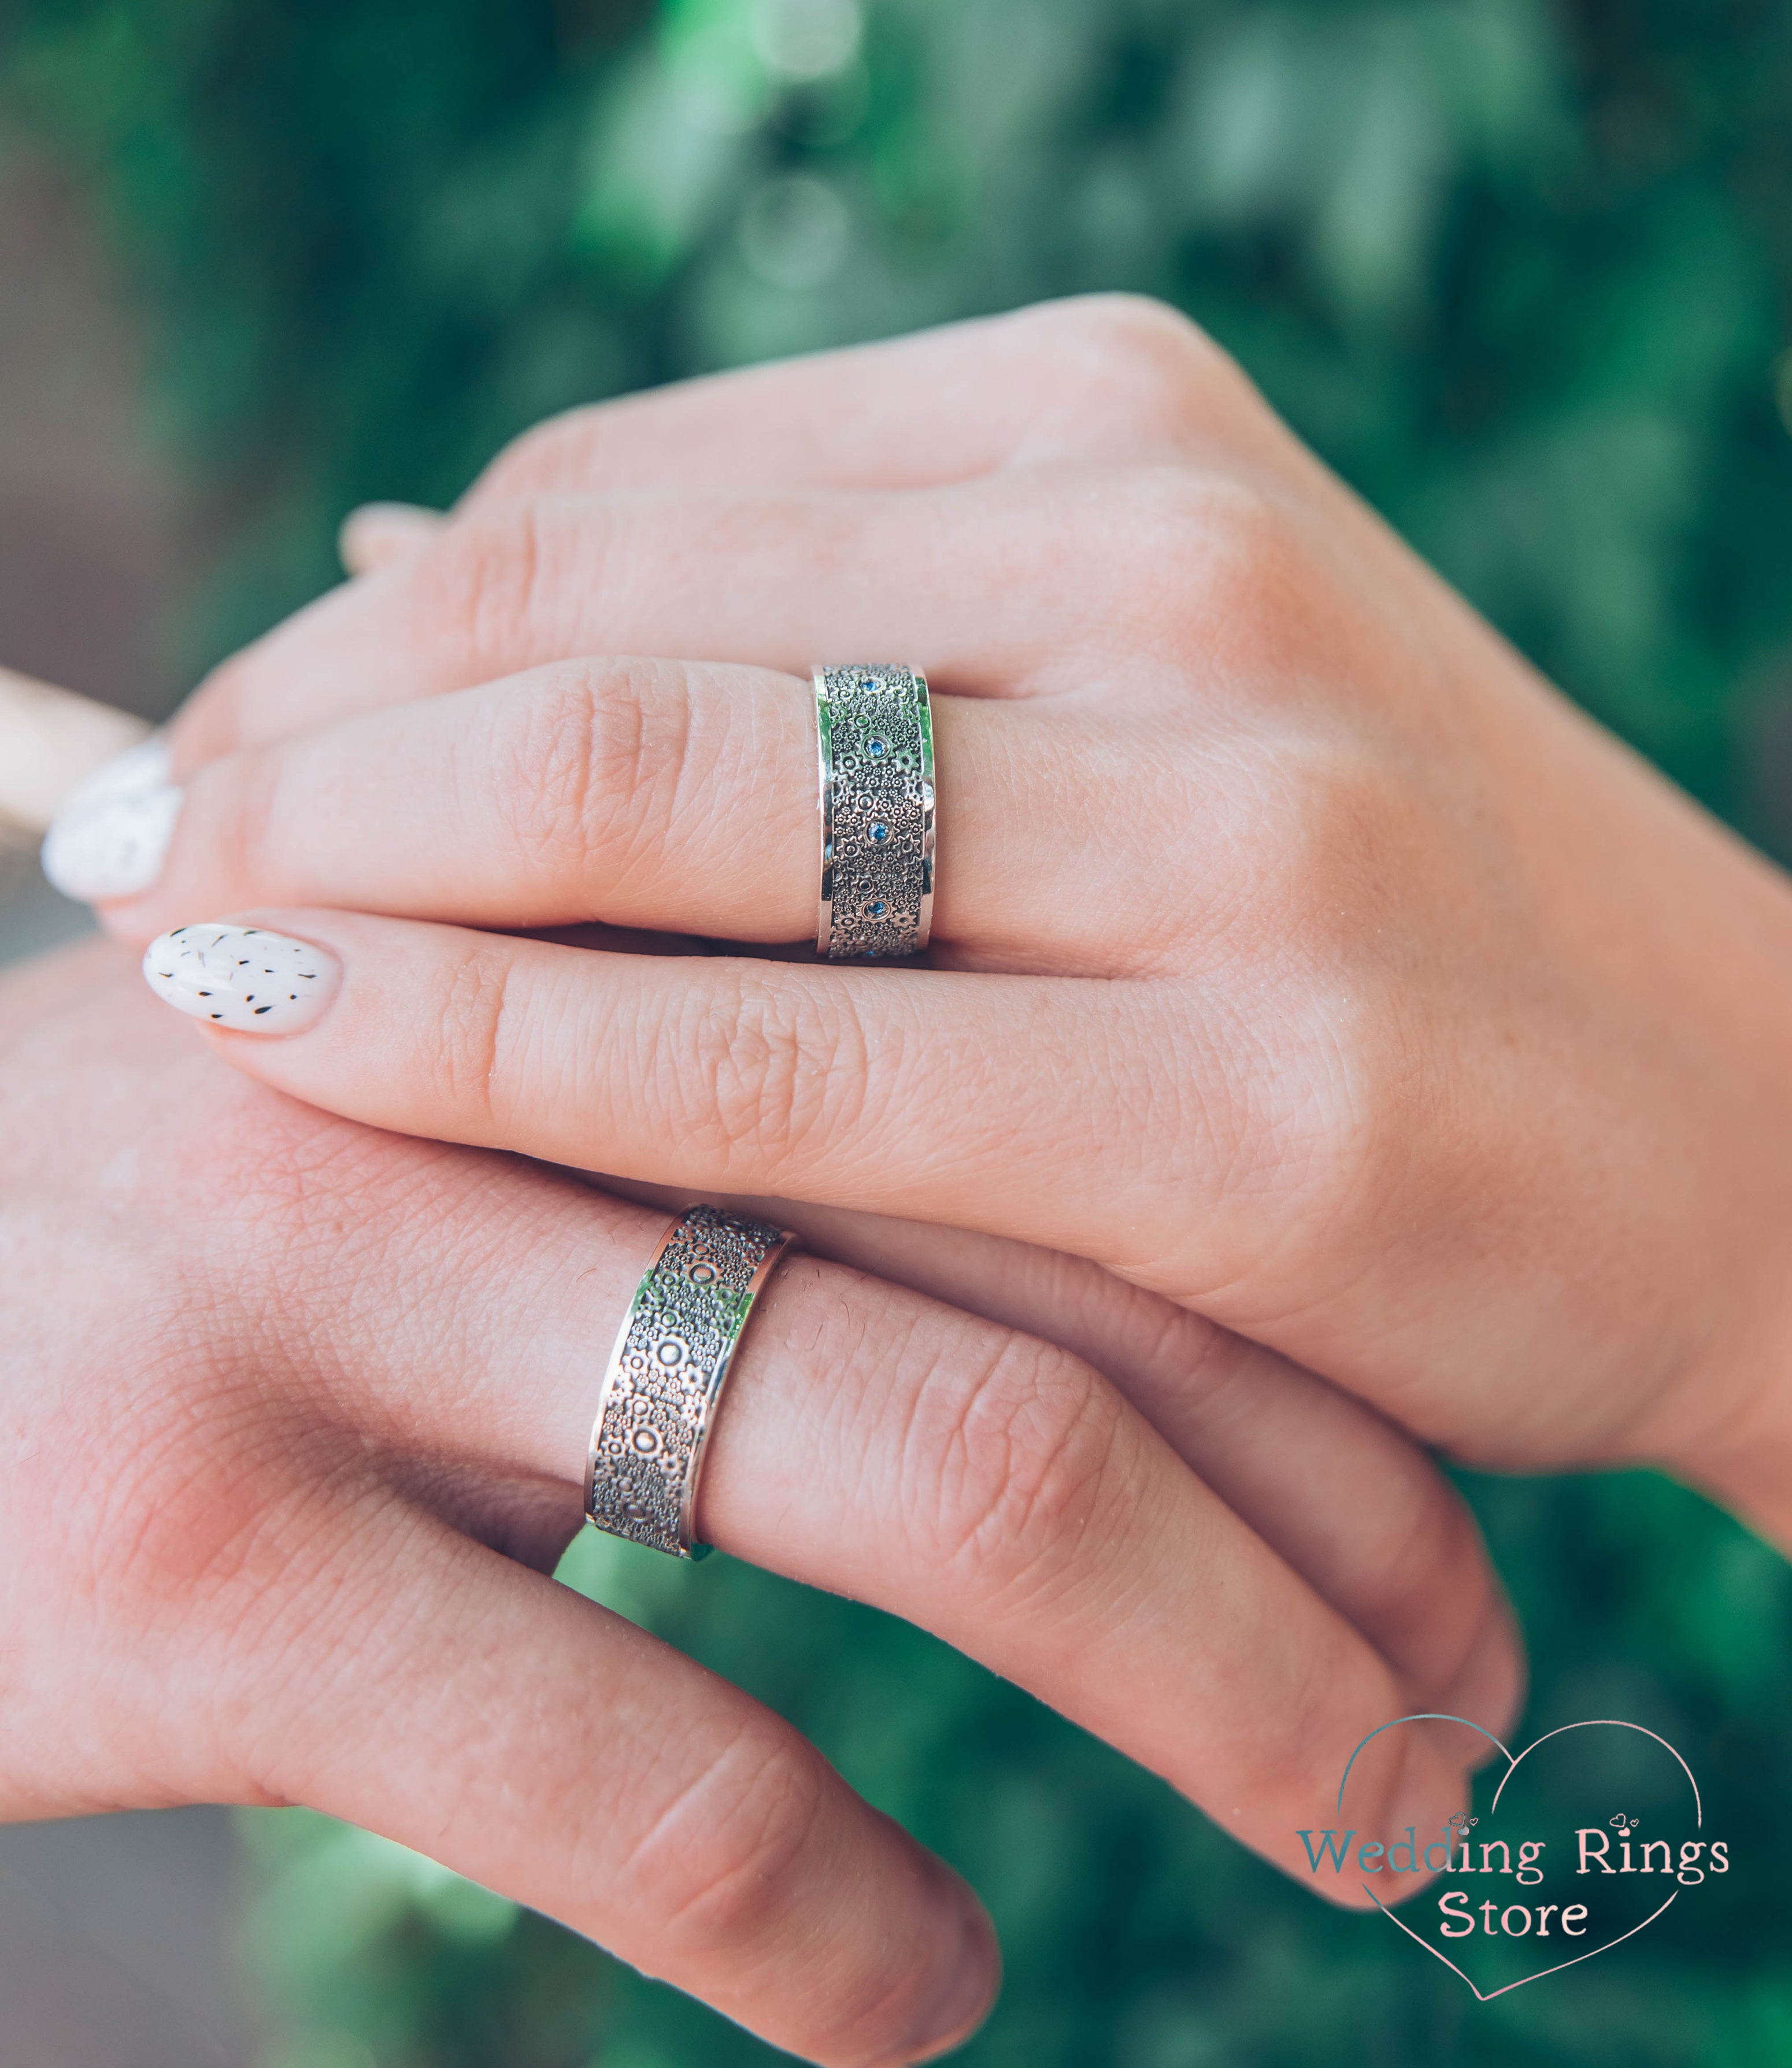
left=10, top=0, right=1792, bottom=2068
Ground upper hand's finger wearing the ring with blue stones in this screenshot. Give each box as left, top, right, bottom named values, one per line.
left=108, top=662, right=1160, bottom=976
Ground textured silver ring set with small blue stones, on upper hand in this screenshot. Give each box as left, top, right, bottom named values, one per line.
left=814, top=666, right=934, bottom=961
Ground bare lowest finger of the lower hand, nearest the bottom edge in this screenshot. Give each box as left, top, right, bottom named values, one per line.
left=217, top=1485, right=996, bottom=2068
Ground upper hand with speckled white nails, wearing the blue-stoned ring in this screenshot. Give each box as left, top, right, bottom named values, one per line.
left=87, top=302, right=1792, bottom=1537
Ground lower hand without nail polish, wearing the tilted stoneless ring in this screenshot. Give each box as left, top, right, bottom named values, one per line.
left=0, top=945, right=1515, bottom=2064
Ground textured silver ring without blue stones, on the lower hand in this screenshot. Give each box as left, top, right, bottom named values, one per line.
left=585, top=1205, right=794, bottom=1557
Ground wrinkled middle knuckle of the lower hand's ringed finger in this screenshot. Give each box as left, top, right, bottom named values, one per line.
left=918, top=1332, right=1124, bottom=1599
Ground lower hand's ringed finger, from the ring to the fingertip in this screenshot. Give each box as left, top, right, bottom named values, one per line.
left=697, top=1257, right=1480, bottom=1900
